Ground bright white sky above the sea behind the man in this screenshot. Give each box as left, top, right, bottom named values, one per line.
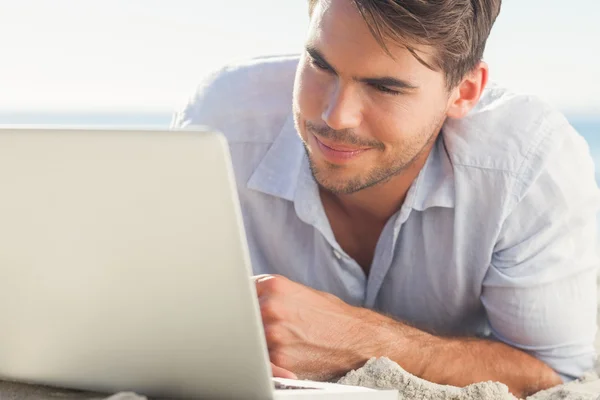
left=0, top=0, right=600, bottom=116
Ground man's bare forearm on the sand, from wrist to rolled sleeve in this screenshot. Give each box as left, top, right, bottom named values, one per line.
left=362, top=310, right=561, bottom=398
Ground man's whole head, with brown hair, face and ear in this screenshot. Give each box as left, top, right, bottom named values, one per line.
left=294, top=0, right=501, bottom=193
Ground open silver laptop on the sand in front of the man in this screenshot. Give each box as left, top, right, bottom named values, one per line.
left=0, top=127, right=397, bottom=399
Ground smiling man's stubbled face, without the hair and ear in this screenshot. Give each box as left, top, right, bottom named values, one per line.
left=294, top=0, right=449, bottom=194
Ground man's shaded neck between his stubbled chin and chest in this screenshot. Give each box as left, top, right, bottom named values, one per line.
left=321, top=141, right=435, bottom=224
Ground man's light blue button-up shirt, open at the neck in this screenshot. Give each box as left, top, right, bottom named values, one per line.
left=173, top=56, right=600, bottom=380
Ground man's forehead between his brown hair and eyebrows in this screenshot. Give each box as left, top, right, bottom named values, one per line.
left=307, top=0, right=437, bottom=78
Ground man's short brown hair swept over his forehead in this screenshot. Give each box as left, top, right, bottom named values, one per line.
left=308, top=0, right=502, bottom=88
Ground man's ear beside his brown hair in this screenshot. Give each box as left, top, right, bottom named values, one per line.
left=446, top=61, right=489, bottom=118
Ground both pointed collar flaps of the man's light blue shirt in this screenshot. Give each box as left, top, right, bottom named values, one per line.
left=247, top=114, right=455, bottom=211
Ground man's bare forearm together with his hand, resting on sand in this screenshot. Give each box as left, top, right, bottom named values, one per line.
left=256, top=276, right=561, bottom=395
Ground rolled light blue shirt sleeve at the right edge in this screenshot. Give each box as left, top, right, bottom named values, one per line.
left=481, top=124, right=600, bottom=381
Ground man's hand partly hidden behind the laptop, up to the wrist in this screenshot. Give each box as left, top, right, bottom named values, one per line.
left=255, top=275, right=369, bottom=380
